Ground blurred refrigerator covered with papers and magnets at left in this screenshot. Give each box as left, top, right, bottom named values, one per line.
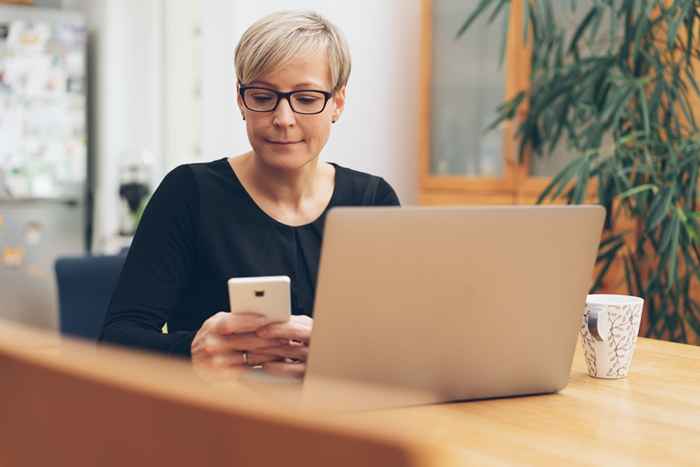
left=0, top=6, right=92, bottom=329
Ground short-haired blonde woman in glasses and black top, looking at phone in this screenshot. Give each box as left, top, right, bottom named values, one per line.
left=101, top=12, right=399, bottom=376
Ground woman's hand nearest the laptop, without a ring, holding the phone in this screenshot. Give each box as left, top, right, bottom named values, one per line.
left=250, top=315, right=314, bottom=378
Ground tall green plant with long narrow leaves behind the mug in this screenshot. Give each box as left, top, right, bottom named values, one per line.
left=457, top=0, right=700, bottom=342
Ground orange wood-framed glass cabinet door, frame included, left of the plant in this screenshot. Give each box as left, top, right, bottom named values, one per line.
left=420, top=0, right=586, bottom=204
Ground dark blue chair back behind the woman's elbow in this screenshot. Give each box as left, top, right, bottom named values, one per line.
left=54, top=254, right=126, bottom=342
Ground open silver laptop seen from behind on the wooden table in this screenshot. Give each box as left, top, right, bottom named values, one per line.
left=304, top=206, right=605, bottom=405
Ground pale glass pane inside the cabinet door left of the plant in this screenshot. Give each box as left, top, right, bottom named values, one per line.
left=430, top=0, right=505, bottom=178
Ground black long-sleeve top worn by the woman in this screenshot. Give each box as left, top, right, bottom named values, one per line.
left=100, top=158, right=399, bottom=356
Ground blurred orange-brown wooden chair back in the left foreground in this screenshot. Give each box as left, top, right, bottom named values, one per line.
left=0, top=321, right=454, bottom=467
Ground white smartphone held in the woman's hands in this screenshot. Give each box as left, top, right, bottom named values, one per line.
left=228, top=276, right=292, bottom=322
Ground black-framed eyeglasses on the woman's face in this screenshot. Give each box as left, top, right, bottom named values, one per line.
left=238, top=85, right=333, bottom=115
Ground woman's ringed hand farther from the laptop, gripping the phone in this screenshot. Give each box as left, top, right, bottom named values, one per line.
left=191, top=311, right=288, bottom=376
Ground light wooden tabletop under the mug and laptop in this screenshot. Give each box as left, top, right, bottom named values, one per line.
left=350, top=339, right=700, bottom=466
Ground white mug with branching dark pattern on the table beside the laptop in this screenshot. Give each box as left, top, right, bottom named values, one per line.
left=581, top=294, right=644, bottom=379
